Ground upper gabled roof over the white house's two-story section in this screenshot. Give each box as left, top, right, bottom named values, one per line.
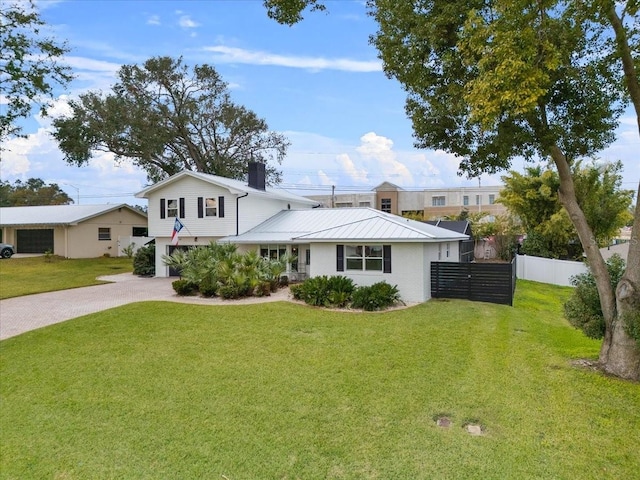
left=135, top=170, right=318, bottom=205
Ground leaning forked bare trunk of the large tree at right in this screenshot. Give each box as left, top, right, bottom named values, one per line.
left=551, top=146, right=640, bottom=380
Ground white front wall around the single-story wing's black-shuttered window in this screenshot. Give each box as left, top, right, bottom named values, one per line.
left=309, top=243, right=430, bottom=303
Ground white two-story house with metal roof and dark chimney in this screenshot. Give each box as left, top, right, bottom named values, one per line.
left=136, top=164, right=469, bottom=302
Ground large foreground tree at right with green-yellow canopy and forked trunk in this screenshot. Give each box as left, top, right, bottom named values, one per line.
left=265, top=0, right=640, bottom=380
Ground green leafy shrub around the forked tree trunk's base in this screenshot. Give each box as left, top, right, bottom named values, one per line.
left=564, top=254, right=624, bottom=339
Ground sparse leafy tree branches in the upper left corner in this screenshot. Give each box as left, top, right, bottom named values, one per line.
left=0, top=0, right=72, bottom=141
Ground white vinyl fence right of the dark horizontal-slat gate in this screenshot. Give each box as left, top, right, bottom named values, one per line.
left=516, top=255, right=589, bottom=287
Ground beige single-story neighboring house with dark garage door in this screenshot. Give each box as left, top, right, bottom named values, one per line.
left=0, top=204, right=147, bottom=258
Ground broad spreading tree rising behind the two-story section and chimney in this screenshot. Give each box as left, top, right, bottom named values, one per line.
left=53, top=57, right=289, bottom=183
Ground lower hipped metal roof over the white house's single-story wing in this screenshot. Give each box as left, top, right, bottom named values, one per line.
left=221, top=207, right=468, bottom=243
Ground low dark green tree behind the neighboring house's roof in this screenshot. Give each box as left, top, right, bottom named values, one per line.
left=0, top=178, right=73, bottom=207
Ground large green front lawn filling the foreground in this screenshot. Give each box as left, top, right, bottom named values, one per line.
left=0, top=281, right=640, bottom=480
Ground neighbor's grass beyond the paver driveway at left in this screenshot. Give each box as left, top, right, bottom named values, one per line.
left=0, top=256, right=133, bottom=299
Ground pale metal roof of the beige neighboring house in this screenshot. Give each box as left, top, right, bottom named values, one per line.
left=0, top=203, right=146, bottom=227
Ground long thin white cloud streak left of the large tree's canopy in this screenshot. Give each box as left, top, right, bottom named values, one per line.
left=204, top=45, right=382, bottom=72
